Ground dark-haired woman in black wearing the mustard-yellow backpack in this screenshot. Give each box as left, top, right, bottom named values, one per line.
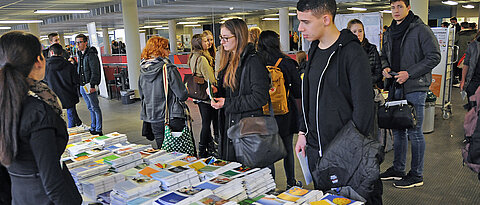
left=257, top=30, right=302, bottom=189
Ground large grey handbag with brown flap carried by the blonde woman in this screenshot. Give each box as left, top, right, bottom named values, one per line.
left=227, top=65, right=287, bottom=168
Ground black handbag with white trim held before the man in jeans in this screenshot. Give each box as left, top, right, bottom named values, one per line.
left=377, top=83, right=417, bottom=129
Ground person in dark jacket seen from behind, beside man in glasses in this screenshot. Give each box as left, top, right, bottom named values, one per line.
left=45, top=44, right=82, bottom=127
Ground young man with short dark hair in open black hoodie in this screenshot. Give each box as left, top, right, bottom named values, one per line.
left=295, top=0, right=381, bottom=204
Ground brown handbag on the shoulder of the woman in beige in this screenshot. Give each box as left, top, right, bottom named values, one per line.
left=184, top=58, right=208, bottom=100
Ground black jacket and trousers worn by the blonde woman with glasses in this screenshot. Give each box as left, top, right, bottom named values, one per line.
left=217, top=44, right=270, bottom=161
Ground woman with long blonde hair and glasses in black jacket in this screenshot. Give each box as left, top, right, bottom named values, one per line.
left=211, top=19, right=270, bottom=161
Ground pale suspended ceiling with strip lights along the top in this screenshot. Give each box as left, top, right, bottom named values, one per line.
left=0, top=0, right=480, bottom=34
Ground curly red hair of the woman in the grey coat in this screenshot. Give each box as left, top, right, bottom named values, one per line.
left=141, top=36, right=170, bottom=59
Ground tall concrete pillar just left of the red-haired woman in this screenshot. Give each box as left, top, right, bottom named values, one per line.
left=122, top=0, right=140, bottom=92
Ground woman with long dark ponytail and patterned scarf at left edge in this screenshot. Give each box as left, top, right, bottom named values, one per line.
left=0, top=31, right=82, bottom=204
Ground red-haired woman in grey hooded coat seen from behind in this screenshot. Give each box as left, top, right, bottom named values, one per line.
left=138, top=36, right=188, bottom=148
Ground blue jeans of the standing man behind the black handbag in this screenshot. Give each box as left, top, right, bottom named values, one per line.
left=393, top=89, right=427, bottom=176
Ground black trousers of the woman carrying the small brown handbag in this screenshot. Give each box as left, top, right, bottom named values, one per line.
left=197, top=102, right=218, bottom=146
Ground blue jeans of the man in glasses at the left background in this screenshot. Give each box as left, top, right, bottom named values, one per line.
left=80, top=87, right=102, bottom=132
